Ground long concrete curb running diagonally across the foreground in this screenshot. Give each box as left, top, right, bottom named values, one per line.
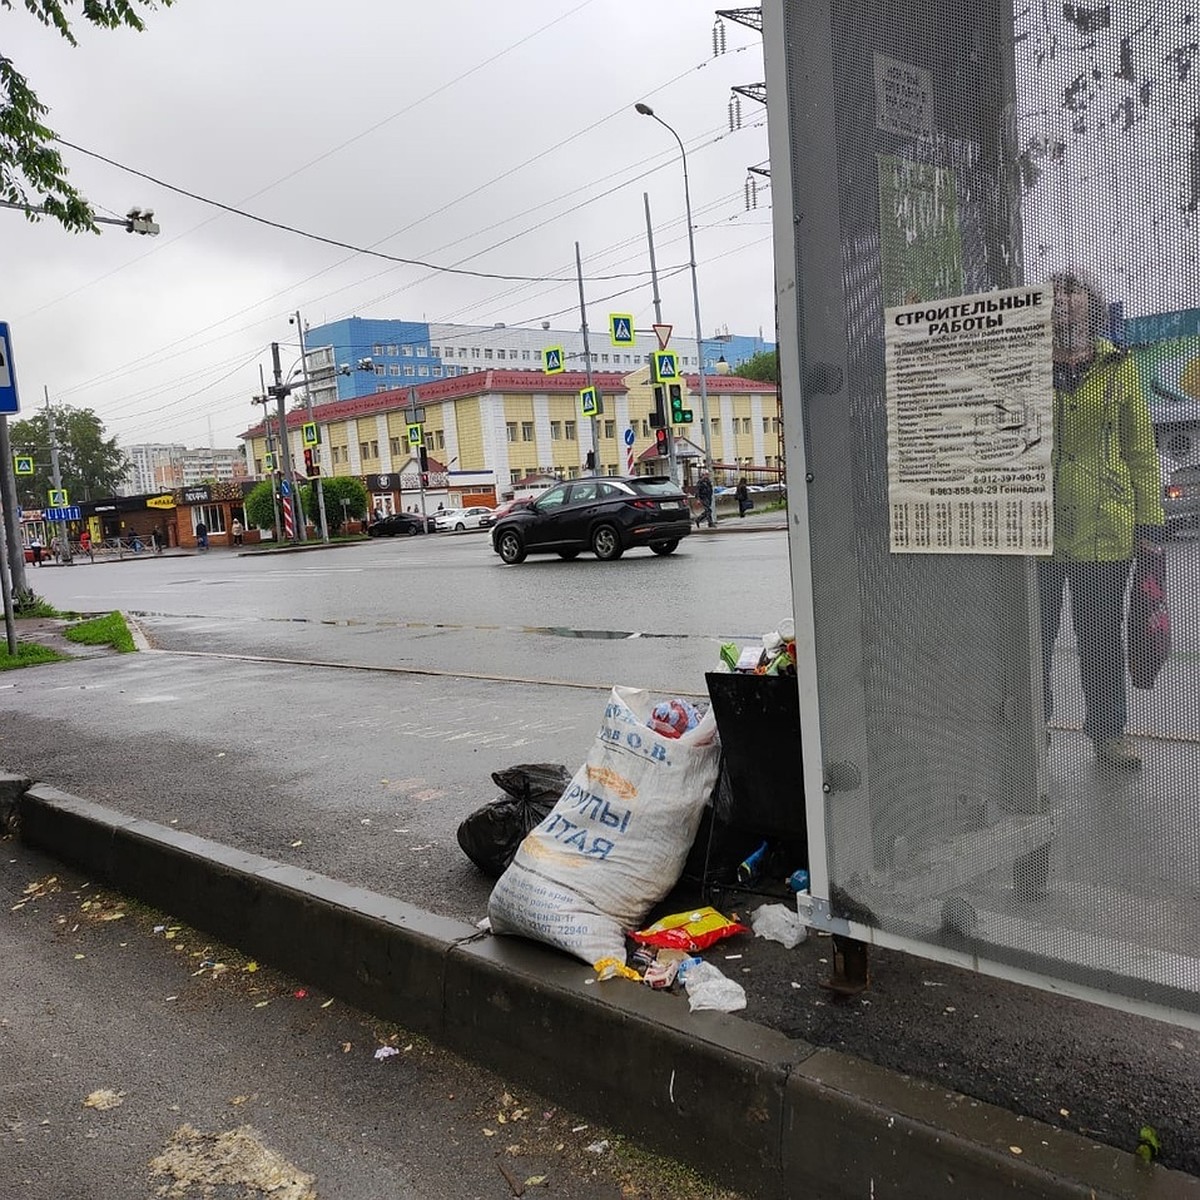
left=11, top=776, right=1200, bottom=1200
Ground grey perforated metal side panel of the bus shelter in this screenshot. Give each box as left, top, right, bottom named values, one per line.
left=763, top=0, right=1200, bottom=1024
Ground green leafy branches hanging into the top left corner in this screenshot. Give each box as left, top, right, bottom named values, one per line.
left=0, top=0, right=174, bottom=233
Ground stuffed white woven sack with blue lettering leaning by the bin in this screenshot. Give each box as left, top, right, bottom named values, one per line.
left=487, top=688, right=720, bottom=965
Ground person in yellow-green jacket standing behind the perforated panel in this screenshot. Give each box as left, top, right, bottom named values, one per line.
left=1038, top=271, right=1165, bottom=770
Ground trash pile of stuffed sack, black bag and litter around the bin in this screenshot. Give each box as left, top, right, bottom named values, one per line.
left=458, top=657, right=808, bottom=1012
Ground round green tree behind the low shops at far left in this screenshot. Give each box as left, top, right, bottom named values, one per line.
left=10, top=404, right=130, bottom=509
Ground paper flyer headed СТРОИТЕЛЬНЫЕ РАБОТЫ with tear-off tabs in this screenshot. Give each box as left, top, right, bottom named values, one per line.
left=886, top=287, right=1054, bottom=554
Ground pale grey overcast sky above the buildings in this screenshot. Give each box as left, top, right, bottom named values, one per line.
left=0, top=0, right=774, bottom=446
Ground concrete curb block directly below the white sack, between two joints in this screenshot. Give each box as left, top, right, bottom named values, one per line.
left=445, top=937, right=812, bottom=1195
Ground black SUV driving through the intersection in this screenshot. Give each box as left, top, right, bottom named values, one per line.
left=492, top=476, right=691, bottom=564
